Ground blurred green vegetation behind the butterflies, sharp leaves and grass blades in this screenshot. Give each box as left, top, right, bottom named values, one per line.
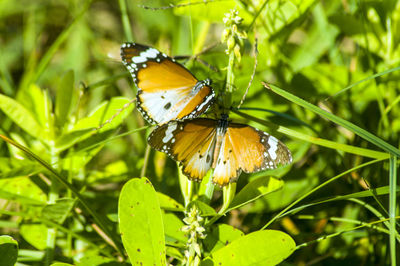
left=0, top=0, right=400, bottom=265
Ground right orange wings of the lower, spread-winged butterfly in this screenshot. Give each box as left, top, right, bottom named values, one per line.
left=213, top=123, right=292, bottom=186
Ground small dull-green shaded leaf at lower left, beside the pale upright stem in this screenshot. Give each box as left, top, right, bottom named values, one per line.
left=42, top=198, right=75, bottom=224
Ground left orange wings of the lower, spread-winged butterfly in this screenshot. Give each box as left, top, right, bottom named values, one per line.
left=148, top=118, right=217, bottom=181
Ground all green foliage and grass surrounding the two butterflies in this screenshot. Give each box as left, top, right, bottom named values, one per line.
left=0, top=0, right=400, bottom=266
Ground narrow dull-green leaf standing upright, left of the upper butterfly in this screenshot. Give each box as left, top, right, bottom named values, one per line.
left=55, top=70, right=74, bottom=127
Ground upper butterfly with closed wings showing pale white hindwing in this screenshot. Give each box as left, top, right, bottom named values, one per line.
left=121, top=43, right=215, bottom=124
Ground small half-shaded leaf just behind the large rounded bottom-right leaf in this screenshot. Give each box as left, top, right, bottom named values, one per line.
left=203, top=224, right=244, bottom=253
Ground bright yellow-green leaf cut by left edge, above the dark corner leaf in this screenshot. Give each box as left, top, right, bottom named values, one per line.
left=0, top=176, right=47, bottom=205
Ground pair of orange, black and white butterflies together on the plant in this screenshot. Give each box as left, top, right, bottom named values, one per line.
left=121, top=43, right=292, bottom=186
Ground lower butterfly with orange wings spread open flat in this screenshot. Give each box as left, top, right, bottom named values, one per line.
left=148, top=115, right=292, bottom=186
